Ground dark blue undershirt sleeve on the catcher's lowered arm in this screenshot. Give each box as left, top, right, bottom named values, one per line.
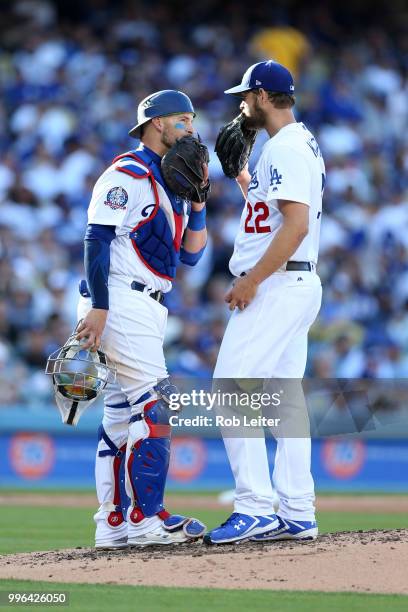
left=84, top=223, right=116, bottom=310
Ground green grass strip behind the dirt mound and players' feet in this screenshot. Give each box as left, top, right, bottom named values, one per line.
left=0, top=506, right=408, bottom=554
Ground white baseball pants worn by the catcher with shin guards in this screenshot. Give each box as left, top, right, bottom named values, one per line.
left=77, top=276, right=168, bottom=541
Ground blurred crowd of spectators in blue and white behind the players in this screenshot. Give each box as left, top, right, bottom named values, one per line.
left=0, top=0, right=408, bottom=405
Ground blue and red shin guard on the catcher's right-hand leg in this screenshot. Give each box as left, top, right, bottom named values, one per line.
left=127, top=399, right=171, bottom=518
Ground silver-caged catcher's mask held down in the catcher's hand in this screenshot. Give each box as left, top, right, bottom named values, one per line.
left=45, top=331, right=116, bottom=425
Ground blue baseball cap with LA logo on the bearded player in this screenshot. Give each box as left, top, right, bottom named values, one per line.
left=224, top=60, right=295, bottom=96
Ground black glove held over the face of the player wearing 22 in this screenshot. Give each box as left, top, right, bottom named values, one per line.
left=214, top=114, right=258, bottom=178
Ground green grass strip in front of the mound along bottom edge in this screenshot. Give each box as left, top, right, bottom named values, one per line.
left=0, top=580, right=408, bottom=612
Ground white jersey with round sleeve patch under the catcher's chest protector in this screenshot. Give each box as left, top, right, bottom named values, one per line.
left=88, top=158, right=188, bottom=292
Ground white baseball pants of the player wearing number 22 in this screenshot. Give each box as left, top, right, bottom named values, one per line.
left=214, top=271, right=322, bottom=520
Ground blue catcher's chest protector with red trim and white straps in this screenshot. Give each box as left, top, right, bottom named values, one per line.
left=114, top=150, right=188, bottom=280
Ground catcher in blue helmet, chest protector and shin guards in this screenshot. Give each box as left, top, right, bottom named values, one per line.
left=48, top=90, right=210, bottom=548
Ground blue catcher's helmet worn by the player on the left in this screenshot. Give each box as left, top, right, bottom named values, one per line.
left=129, top=89, right=195, bottom=138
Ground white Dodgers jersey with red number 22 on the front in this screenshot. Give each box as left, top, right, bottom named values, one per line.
left=230, top=123, right=325, bottom=276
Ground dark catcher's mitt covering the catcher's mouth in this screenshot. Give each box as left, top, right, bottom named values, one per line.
left=161, top=136, right=210, bottom=202
